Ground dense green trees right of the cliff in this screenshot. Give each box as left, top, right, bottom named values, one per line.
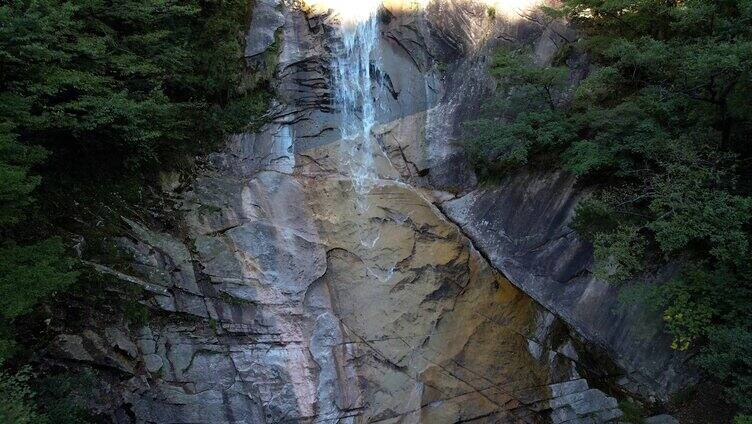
left=468, top=0, right=752, bottom=411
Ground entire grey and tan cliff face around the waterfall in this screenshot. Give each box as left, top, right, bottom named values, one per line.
left=50, top=0, right=682, bottom=423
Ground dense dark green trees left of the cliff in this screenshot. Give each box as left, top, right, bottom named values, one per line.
left=0, top=0, right=269, bottom=422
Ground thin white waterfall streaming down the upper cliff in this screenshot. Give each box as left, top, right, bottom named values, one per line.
left=333, top=10, right=379, bottom=213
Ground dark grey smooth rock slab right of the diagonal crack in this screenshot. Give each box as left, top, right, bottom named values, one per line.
left=442, top=172, right=693, bottom=399
